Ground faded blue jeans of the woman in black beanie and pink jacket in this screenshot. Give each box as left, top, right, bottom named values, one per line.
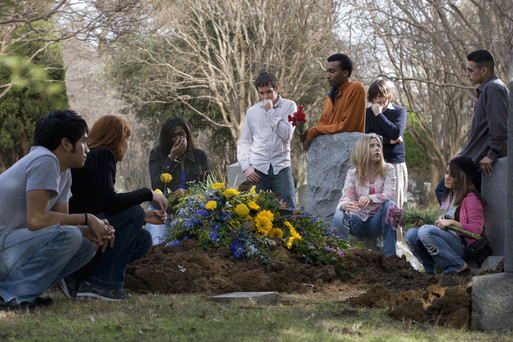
left=404, top=225, right=465, bottom=273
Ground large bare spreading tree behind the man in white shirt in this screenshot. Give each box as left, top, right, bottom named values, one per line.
left=104, top=0, right=340, bottom=182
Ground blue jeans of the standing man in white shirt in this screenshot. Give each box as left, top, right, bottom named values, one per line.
left=255, top=165, right=296, bottom=208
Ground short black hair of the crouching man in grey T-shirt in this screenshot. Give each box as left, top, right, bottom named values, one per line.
left=34, top=110, right=88, bottom=151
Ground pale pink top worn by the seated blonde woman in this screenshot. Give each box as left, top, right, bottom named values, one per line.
left=336, top=163, right=395, bottom=221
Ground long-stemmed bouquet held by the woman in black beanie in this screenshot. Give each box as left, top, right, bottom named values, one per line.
left=385, top=204, right=481, bottom=240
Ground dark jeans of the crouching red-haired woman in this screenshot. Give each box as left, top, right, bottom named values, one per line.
left=73, top=205, right=152, bottom=290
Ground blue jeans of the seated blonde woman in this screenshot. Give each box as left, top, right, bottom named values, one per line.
left=332, top=201, right=397, bottom=256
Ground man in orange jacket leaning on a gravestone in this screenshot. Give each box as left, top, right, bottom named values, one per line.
left=301, top=53, right=366, bottom=151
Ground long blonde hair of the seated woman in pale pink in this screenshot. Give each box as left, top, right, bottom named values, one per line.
left=351, top=133, right=385, bottom=185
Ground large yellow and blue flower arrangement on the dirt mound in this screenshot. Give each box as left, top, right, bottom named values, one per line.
left=165, top=177, right=355, bottom=275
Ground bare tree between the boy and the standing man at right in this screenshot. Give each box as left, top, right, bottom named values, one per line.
left=341, top=0, right=513, bottom=200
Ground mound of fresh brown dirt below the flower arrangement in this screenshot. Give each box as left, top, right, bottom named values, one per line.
left=125, top=240, right=500, bottom=328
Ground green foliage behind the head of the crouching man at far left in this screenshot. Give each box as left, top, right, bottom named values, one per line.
left=0, top=23, right=68, bottom=168
